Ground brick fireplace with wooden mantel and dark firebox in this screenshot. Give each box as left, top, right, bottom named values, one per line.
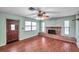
left=46, top=26, right=61, bottom=35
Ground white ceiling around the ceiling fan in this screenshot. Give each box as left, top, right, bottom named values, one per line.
left=0, top=7, right=79, bottom=18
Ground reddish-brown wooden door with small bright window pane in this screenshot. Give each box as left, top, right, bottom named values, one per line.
left=6, top=19, right=19, bottom=43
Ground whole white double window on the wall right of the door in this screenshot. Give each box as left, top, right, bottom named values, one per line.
left=25, top=21, right=37, bottom=31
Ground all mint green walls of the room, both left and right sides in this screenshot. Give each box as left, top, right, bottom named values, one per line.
left=0, top=13, right=79, bottom=46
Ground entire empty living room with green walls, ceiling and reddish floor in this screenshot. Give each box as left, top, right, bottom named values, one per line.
left=0, top=7, right=79, bottom=52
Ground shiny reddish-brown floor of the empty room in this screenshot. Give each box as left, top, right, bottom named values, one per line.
left=0, top=36, right=79, bottom=52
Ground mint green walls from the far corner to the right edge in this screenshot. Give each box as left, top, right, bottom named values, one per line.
left=37, top=16, right=79, bottom=47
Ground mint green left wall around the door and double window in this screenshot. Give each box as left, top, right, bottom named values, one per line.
left=0, top=13, right=39, bottom=46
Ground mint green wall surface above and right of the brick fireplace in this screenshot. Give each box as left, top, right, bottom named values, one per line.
left=43, top=16, right=76, bottom=37
